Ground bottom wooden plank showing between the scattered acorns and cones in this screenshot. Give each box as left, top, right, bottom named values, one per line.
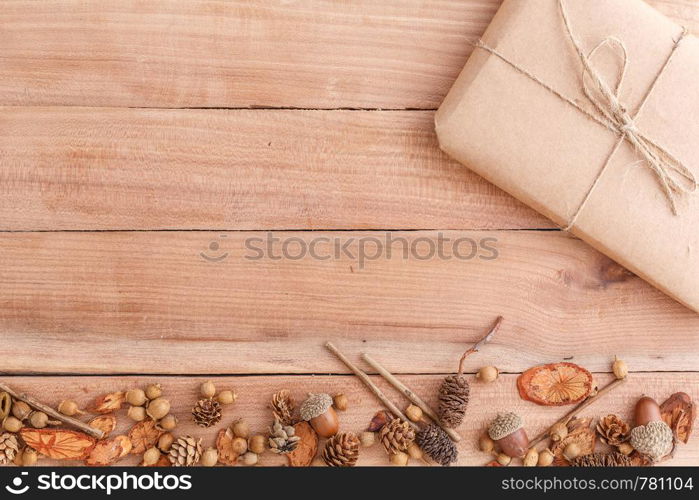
left=3, top=374, right=699, bottom=465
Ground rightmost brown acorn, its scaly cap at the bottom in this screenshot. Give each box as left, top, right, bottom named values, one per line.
left=629, top=396, right=674, bottom=461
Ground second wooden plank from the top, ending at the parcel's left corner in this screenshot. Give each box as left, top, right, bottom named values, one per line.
left=0, top=107, right=551, bottom=230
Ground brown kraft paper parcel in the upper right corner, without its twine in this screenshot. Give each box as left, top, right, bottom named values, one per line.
left=435, top=0, right=699, bottom=312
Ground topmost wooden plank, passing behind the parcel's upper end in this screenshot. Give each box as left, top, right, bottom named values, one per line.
left=0, top=0, right=699, bottom=109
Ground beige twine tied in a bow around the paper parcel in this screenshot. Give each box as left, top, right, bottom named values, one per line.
left=475, top=0, right=697, bottom=230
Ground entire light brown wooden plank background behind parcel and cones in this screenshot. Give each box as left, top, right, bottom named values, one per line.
left=0, top=0, right=699, bottom=465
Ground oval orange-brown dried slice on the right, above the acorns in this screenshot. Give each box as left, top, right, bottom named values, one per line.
left=517, top=363, right=592, bottom=406
